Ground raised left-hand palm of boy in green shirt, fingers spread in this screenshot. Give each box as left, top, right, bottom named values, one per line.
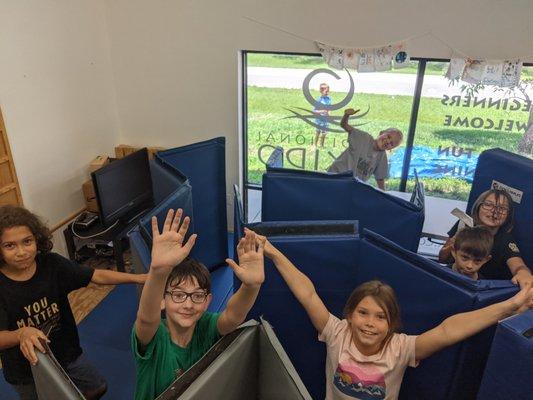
left=150, top=208, right=196, bottom=271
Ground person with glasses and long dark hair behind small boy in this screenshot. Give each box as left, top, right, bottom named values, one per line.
left=439, top=189, right=533, bottom=288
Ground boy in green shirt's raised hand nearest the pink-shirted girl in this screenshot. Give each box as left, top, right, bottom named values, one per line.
left=226, top=229, right=265, bottom=286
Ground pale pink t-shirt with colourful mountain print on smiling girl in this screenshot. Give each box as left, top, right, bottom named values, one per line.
left=318, top=314, right=418, bottom=400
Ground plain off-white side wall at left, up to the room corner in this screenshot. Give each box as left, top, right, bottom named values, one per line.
left=0, top=0, right=119, bottom=225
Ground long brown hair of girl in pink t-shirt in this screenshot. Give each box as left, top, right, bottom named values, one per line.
left=343, top=280, right=401, bottom=348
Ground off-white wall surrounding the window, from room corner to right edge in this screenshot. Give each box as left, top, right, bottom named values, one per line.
left=104, top=0, right=533, bottom=223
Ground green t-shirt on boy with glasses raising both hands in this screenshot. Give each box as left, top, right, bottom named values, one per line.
left=131, top=312, right=221, bottom=400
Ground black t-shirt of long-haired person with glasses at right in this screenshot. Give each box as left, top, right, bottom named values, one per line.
left=448, top=223, right=522, bottom=280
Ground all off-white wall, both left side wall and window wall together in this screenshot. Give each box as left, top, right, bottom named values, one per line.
left=0, top=0, right=533, bottom=228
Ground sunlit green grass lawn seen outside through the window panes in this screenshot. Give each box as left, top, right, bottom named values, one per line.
left=248, top=87, right=527, bottom=200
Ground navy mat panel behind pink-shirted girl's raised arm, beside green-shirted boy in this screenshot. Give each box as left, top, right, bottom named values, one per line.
left=248, top=235, right=359, bottom=399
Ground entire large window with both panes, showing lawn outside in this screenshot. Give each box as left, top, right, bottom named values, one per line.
left=243, top=52, right=533, bottom=200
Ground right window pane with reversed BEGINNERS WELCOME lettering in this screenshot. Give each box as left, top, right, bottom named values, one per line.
left=407, top=62, right=533, bottom=200
